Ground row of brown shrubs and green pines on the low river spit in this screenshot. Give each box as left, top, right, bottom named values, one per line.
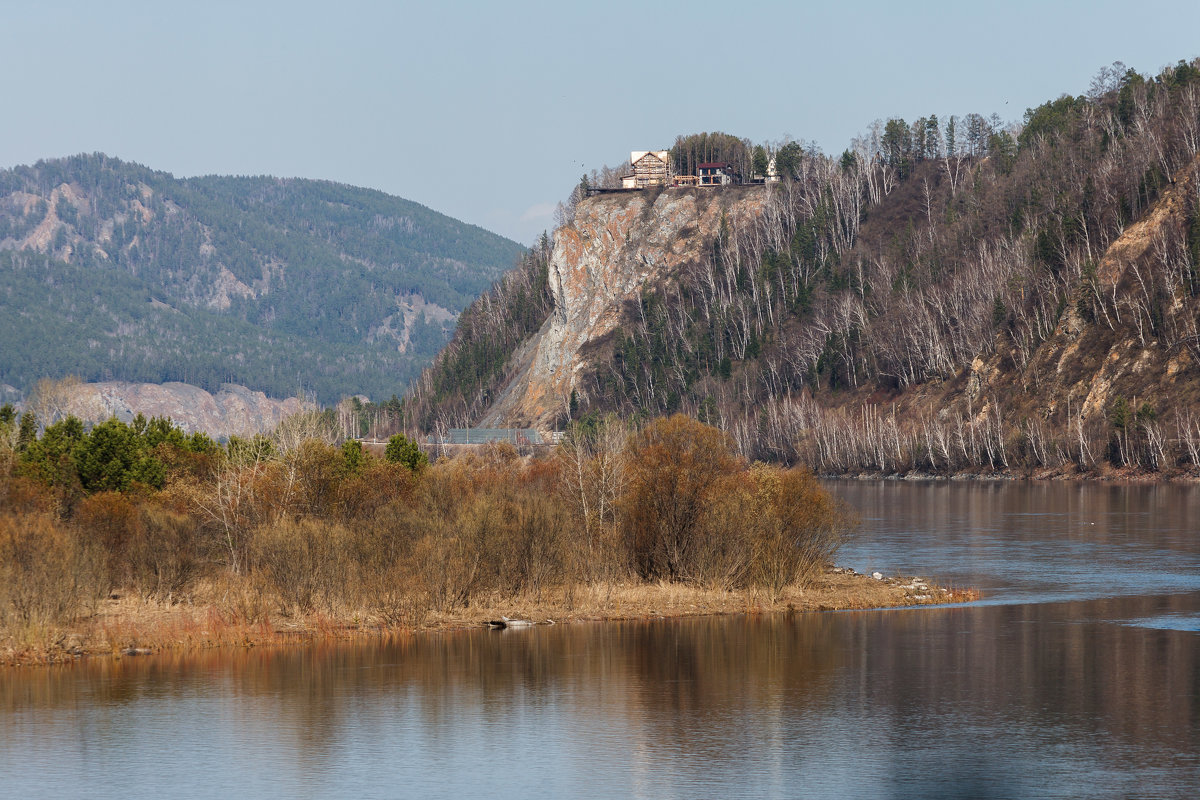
left=0, top=407, right=851, bottom=638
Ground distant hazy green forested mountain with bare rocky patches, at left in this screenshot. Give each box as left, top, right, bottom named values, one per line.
left=0, top=154, right=522, bottom=403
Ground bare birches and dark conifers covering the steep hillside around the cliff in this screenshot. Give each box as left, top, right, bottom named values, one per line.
left=408, top=60, right=1200, bottom=471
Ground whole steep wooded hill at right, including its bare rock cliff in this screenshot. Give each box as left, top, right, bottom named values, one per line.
left=407, top=61, right=1200, bottom=479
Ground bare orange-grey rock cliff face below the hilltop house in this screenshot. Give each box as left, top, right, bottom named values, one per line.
left=480, top=186, right=767, bottom=427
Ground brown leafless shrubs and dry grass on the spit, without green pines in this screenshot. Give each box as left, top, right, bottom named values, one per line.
left=0, top=416, right=960, bottom=661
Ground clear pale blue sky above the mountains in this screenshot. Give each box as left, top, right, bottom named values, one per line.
left=0, top=0, right=1200, bottom=245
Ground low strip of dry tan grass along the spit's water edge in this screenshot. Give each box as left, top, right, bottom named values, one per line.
left=0, top=567, right=979, bottom=666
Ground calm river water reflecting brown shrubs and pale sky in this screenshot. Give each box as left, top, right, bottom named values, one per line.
left=0, top=481, right=1200, bottom=800
